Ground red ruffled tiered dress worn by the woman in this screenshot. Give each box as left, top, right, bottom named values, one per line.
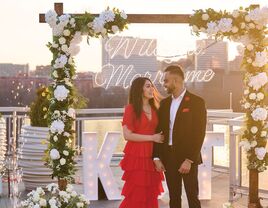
left=119, top=104, right=164, bottom=208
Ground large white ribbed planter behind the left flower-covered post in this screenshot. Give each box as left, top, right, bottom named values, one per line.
left=19, top=125, right=82, bottom=190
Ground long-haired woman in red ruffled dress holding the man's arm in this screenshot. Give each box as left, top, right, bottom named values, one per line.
left=119, top=77, right=164, bottom=208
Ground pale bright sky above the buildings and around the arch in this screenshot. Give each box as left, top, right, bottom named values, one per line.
left=0, top=0, right=268, bottom=71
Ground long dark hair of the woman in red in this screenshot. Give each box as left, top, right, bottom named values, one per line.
left=128, top=77, right=161, bottom=118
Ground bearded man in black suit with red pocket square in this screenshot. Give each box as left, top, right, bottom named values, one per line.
left=153, top=65, right=207, bottom=208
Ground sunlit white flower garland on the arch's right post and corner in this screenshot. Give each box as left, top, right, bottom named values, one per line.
left=190, top=5, right=268, bottom=172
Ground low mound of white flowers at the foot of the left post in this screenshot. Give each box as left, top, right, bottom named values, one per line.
left=20, top=183, right=89, bottom=208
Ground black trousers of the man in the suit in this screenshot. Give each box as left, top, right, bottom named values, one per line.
left=165, top=146, right=201, bottom=208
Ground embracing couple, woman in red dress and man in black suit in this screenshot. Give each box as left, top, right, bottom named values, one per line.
left=119, top=65, right=207, bottom=208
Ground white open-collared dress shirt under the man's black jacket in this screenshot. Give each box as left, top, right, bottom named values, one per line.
left=168, top=89, right=186, bottom=145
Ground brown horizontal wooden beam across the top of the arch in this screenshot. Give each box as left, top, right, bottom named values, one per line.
left=39, top=14, right=190, bottom=23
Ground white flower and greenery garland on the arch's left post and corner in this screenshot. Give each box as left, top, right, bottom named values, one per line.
left=45, top=8, right=127, bottom=184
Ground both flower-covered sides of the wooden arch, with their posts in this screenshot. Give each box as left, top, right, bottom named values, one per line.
left=22, top=2, right=268, bottom=207
